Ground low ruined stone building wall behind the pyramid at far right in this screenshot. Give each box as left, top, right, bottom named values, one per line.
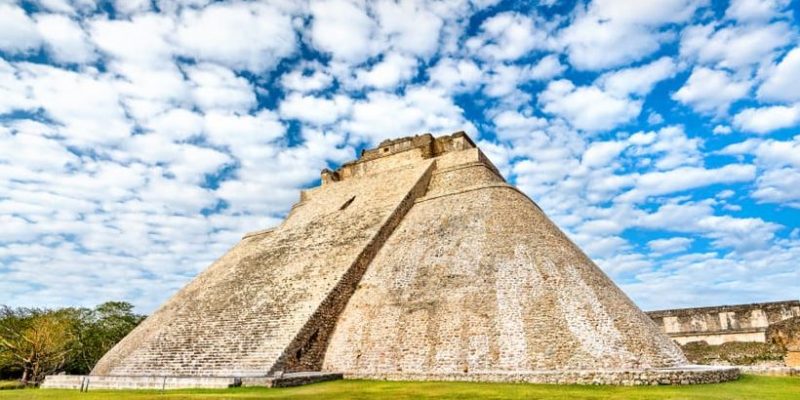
left=647, top=300, right=800, bottom=345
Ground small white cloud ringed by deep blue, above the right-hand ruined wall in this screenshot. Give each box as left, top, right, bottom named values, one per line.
left=672, top=67, right=751, bottom=114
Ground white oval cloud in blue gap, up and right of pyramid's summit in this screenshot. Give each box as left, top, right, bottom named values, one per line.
left=539, top=79, right=642, bottom=131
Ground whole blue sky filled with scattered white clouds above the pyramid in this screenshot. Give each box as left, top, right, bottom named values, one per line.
left=0, top=0, right=800, bottom=312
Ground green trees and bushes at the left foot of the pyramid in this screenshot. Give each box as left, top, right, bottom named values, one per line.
left=0, top=301, right=145, bottom=385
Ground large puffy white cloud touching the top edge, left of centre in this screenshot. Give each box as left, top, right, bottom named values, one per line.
left=175, top=3, right=297, bottom=72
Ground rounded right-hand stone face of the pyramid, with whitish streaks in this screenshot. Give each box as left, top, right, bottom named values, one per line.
left=324, top=149, right=686, bottom=379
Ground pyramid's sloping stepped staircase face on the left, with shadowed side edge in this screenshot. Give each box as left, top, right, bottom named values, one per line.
left=92, top=155, right=432, bottom=376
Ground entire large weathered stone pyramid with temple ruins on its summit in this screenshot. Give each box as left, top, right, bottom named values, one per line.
left=44, top=132, right=739, bottom=387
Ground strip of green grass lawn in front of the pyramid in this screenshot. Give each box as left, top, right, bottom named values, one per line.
left=0, top=375, right=800, bottom=400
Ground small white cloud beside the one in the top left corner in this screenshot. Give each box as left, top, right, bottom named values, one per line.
left=36, top=14, right=96, bottom=64
